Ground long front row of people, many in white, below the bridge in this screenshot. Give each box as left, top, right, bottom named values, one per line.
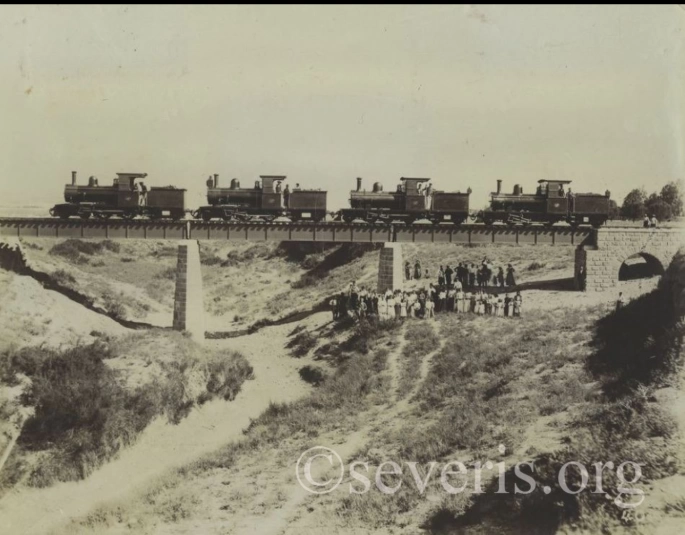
left=329, top=280, right=523, bottom=320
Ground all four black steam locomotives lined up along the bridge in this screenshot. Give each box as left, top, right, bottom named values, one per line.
left=50, top=171, right=611, bottom=227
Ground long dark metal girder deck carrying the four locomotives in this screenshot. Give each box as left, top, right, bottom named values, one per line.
left=0, top=217, right=593, bottom=245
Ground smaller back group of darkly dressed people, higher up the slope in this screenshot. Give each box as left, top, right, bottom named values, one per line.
left=404, top=257, right=516, bottom=289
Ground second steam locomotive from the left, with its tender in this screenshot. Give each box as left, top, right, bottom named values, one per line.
left=191, top=175, right=327, bottom=222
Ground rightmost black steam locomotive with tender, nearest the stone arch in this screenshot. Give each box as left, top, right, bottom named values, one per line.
left=477, top=180, right=611, bottom=228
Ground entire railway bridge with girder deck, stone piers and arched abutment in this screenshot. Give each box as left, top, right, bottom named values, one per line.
left=0, top=218, right=685, bottom=339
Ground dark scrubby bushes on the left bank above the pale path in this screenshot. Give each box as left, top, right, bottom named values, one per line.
left=0, top=339, right=253, bottom=487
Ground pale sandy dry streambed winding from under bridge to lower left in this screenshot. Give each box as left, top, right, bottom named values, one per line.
left=0, top=313, right=329, bottom=535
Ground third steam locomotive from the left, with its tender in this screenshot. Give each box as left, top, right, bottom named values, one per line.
left=340, top=177, right=471, bottom=225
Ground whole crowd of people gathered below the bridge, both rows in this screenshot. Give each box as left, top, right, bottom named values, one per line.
left=329, top=258, right=523, bottom=320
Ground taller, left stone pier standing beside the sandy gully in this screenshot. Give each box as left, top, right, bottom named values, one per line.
left=173, top=240, right=205, bottom=343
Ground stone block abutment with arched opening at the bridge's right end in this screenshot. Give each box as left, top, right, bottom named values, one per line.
left=575, top=228, right=685, bottom=291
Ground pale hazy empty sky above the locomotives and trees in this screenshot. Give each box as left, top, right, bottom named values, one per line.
left=0, top=5, right=685, bottom=208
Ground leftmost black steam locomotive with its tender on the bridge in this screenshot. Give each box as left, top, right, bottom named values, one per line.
left=50, top=171, right=186, bottom=220
